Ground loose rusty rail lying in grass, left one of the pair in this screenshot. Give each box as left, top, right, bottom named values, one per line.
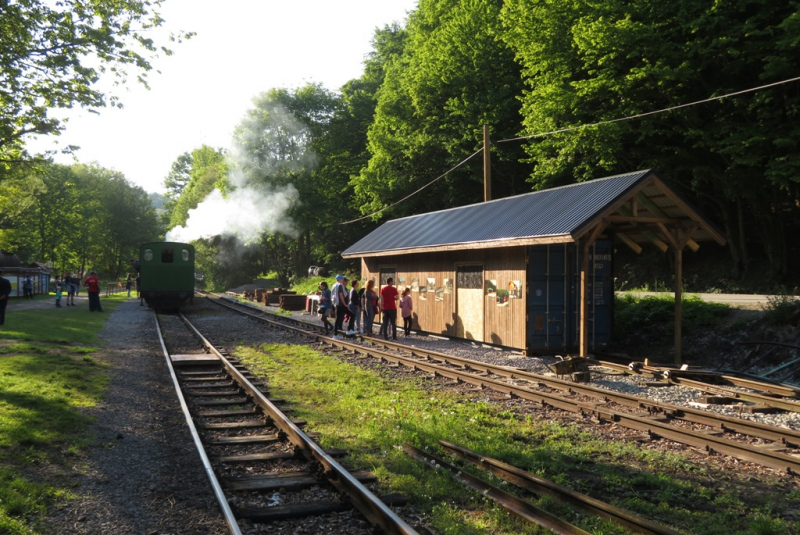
left=403, top=444, right=591, bottom=535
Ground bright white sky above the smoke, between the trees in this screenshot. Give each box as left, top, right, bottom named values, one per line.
left=29, top=0, right=417, bottom=196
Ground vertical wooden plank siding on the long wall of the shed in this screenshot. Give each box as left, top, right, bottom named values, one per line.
left=361, top=247, right=528, bottom=348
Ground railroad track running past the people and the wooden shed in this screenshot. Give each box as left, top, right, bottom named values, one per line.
left=206, top=297, right=800, bottom=475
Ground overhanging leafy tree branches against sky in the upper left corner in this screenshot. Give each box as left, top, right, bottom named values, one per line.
left=0, top=0, right=191, bottom=173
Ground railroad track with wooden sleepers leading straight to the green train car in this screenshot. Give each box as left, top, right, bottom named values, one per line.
left=155, top=308, right=417, bottom=535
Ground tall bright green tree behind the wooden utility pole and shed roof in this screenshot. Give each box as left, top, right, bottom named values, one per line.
left=355, top=0, right=527, bottom=222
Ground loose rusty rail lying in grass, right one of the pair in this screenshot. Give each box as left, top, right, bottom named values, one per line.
left=439, top=440, right=680, bottom=535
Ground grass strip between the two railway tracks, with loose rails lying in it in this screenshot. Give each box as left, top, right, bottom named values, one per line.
left=239, top=345, right=800, bottom=535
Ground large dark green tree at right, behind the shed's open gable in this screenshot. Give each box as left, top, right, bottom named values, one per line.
left=501, top=0, right=800, bottom=277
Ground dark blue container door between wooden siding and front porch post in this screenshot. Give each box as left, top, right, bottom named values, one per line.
left=528, top=244, right=569, bottom=352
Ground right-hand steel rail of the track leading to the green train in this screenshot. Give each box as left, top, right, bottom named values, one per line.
left=174, top=313, right=417, bottom=535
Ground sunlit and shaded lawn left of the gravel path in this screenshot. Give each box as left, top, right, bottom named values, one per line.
left=0, top=294, right=125, bottom=535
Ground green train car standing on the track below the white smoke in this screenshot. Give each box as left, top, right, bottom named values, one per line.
left=138, top=242, right=195, bottom=310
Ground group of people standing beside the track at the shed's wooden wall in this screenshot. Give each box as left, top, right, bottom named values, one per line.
left=318, top=275, right=414, bottom=340
